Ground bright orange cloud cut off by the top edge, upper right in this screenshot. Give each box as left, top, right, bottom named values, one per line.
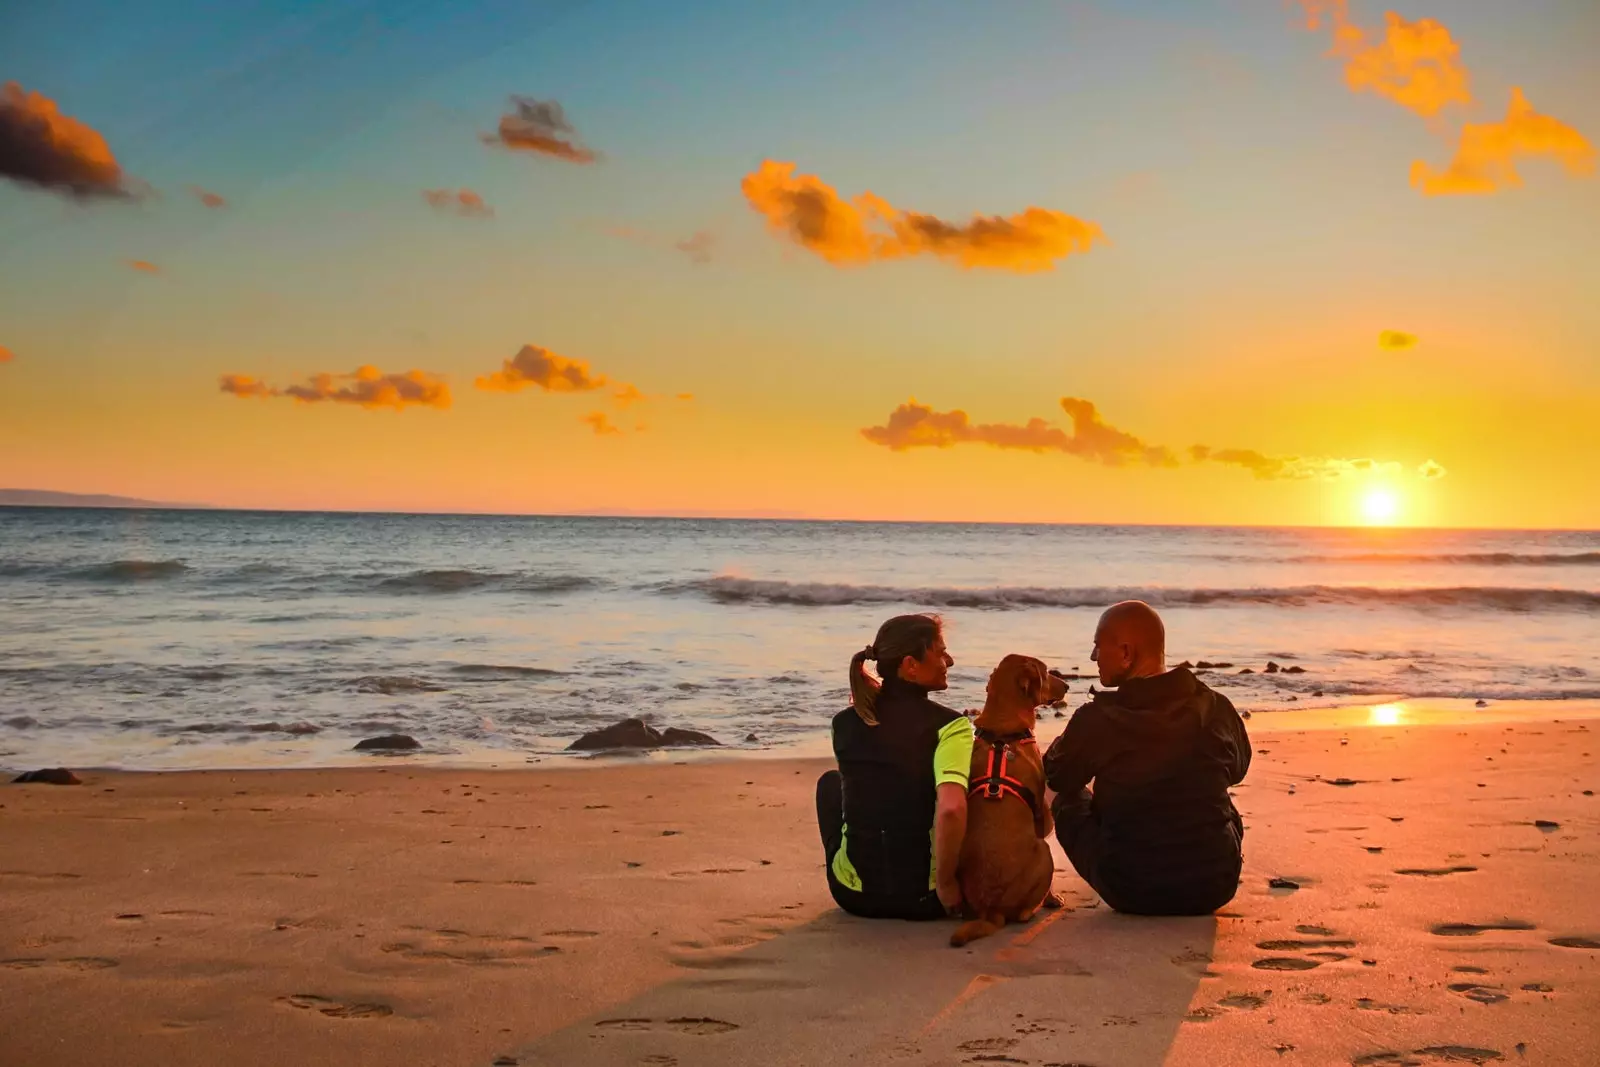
left=1301, top=0, right=1472, bottom=118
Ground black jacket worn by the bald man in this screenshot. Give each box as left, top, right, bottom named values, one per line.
left=1045, top=667, right=1250, bottom=896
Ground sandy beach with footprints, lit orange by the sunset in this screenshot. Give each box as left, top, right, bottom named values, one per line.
left=0, top=702, right=1600, bottom=1067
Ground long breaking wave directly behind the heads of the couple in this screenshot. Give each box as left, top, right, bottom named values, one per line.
left=656, top=576, right=1600, bottom=613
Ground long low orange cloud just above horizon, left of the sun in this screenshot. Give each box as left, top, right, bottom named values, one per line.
left=861, top=397, right=1178, bottom=467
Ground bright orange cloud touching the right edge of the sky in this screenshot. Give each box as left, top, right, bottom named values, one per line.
left=1411, top=88, right=1595, bottom=197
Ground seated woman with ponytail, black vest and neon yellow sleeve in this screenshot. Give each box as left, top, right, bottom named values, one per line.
left=816, top=614, right=973, bottom=918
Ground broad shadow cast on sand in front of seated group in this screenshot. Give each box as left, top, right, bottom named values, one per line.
left=494, top=902, right=1216, bottom=1067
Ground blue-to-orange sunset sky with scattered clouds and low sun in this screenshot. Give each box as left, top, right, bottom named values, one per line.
left=0, top=0, right=1600, bottom=528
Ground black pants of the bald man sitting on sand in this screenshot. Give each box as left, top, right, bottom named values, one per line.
left=1050, top=789, right=1245, bottom=915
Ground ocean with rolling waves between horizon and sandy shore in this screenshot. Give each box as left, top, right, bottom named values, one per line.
left=0, top=507, right=1600, bottom=768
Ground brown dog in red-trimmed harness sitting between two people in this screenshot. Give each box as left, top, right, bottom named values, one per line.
left=950, top=656, right=1067, bottom=945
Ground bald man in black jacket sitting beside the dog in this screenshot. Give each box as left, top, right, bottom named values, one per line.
left=1045, top=600, right=1250, bottom=915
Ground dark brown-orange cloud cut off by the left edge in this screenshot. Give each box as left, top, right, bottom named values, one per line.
left=0, top=82, right=133, bottom=200
